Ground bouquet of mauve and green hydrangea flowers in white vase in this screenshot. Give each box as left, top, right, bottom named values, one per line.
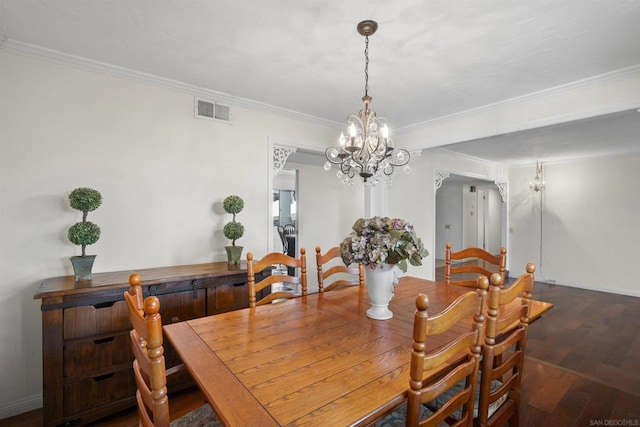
left=340, top=216, right=429, bottom=273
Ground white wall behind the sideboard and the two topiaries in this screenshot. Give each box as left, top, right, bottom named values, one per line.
left=0, top=53, right=335, bottom=418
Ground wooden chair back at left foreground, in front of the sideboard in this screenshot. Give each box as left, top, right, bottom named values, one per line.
left=124, top=274, right=170, bottom=427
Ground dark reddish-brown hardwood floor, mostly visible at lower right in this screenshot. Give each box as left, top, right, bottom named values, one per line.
left=0, top=269, right=640, bottom=427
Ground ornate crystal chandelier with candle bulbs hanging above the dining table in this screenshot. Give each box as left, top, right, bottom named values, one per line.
left=324, top=20, right=411, bottom=185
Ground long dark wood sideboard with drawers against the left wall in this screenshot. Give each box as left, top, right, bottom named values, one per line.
left=34, top=262, right=268, bottom=426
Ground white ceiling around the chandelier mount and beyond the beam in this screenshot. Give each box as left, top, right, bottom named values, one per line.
left=0, top=0, right=640, bottom=163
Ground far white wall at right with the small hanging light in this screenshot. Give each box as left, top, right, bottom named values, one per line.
left=507, top=154, right=640, bottom=296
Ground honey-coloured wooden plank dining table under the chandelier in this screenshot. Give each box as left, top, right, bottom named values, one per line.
left=164, top=276, right=553, bottom=427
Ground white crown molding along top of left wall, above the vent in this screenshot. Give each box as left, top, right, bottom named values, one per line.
left=0, top=39, right=341, bottom=128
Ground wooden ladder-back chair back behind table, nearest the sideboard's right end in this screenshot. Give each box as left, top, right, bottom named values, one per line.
left=247, top=248, right=307, bottom=307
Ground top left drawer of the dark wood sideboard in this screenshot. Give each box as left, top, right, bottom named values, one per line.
left=63, top=297, right=131, bottom=340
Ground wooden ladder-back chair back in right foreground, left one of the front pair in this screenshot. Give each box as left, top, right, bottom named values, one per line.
left=406, top=280, right=488, bottom=426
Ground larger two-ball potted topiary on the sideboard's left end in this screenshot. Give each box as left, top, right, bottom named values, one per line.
left=67, top=187, right=102, bottom=281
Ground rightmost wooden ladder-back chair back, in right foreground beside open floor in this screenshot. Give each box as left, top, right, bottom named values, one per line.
left=477, top=263, right=535, bottom=426
